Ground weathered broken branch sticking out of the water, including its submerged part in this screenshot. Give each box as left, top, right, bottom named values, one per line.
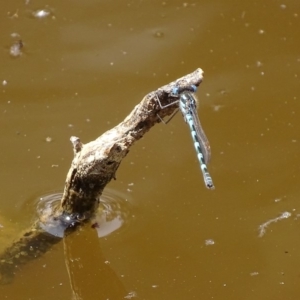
left=0, top=69, right=203, bottom=283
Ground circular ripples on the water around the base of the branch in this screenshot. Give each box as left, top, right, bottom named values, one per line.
left=37, top=189, right=132, bottom=237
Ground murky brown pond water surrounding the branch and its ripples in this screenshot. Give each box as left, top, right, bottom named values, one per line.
left=0, top=0, right=300, bottom=300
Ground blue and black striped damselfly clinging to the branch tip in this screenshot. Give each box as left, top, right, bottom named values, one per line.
left=158, top=86, right=215, bottom=189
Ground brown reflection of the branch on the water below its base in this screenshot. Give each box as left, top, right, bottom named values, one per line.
left=63, top=226, right=127, bottom=300
